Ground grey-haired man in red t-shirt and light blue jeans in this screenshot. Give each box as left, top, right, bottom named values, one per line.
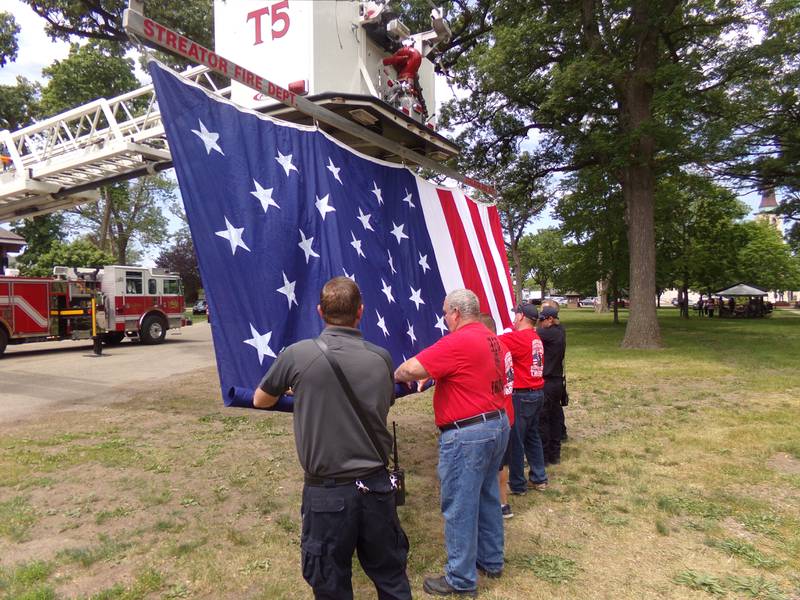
left=395, top=290, right=509, bottom=596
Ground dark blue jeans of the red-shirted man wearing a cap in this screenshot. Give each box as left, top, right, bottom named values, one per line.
left=508, top=390, right=547, bottom=492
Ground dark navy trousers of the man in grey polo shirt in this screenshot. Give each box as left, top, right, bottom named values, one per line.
left=300, top=473, right=411, bottom=600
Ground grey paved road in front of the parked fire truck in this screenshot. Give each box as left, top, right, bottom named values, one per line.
left=0, top=323, right=214, bottom=425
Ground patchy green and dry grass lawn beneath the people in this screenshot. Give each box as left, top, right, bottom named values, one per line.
left=0, top=309, right=800, bottom=600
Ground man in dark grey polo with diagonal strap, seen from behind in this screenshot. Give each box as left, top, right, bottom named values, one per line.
left=253, top=277, right=411, bottom=600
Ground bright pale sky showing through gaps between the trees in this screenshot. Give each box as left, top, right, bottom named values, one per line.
left=0, top=0, right=772, bottom=246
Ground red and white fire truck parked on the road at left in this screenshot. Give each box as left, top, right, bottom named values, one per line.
left=0, top=265, right=187, bottom=355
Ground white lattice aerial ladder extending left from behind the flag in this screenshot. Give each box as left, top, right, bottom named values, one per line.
left=0, top=66, right=230, bottom=223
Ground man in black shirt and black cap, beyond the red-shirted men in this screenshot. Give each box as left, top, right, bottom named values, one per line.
left=536, top=305, right=567, bottom=465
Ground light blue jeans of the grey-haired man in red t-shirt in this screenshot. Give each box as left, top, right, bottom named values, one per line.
left=439, top=414, right=509, bottom=590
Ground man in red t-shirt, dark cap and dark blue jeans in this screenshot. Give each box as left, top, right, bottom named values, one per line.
left=500, top=303, right=547, bottom=494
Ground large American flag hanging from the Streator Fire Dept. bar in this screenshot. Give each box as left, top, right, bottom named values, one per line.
left=150, top=63, right=513, bottom=403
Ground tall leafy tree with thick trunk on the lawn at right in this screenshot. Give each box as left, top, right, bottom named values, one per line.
left=440, top=0, right=768, bottom=348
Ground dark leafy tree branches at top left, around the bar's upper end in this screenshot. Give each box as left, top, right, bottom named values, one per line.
left=23, top=0, right=214, bottom=65
